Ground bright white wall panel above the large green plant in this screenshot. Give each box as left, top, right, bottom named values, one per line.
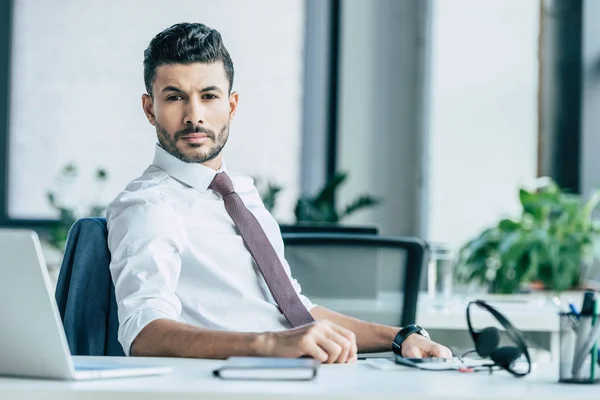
left=427, top=0, right=539, bottom=245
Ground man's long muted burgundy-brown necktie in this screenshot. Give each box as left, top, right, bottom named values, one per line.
left=208, top=172, right=314, bottom=327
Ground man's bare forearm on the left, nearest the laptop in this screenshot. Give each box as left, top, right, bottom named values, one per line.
left=131, top=319, right=269, bottom=359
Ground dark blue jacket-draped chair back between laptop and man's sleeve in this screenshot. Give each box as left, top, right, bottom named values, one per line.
left=56, top=218, right=124, bottom=356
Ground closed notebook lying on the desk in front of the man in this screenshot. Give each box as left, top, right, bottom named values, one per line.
left=213, top=357, right=320, bottom=381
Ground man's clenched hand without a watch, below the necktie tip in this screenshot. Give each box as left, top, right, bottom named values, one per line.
left=261, top=321, right=357, bottom=364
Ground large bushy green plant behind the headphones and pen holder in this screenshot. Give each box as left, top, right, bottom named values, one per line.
left=455, top=178, right=600, bottom=293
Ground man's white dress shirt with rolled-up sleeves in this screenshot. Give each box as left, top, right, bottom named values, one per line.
left=107, top=145, right=314, bottom=355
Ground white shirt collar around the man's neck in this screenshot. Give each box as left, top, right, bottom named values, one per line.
left=152, top=143, right=227, bottom=193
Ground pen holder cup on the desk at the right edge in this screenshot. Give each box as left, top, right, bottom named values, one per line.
left=558, top=313, right=600, bottom=383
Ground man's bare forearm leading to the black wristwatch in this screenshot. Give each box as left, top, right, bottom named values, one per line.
left=310, top=306, right=400, bottom=353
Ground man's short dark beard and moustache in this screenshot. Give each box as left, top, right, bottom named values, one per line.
left=156, top=123, right=229, bottom=163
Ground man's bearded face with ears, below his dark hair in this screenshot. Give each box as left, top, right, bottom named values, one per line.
left=142, top=62, right=238, bottom=170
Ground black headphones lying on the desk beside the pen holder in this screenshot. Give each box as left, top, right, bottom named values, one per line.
left=467, top=300, right=531, bottom=377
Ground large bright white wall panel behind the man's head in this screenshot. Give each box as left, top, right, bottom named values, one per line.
left=9, top=0, right=304, bottom=220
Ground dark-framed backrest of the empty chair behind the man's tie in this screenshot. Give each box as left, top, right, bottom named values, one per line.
left=283, top=233, right=429, bottom=326
